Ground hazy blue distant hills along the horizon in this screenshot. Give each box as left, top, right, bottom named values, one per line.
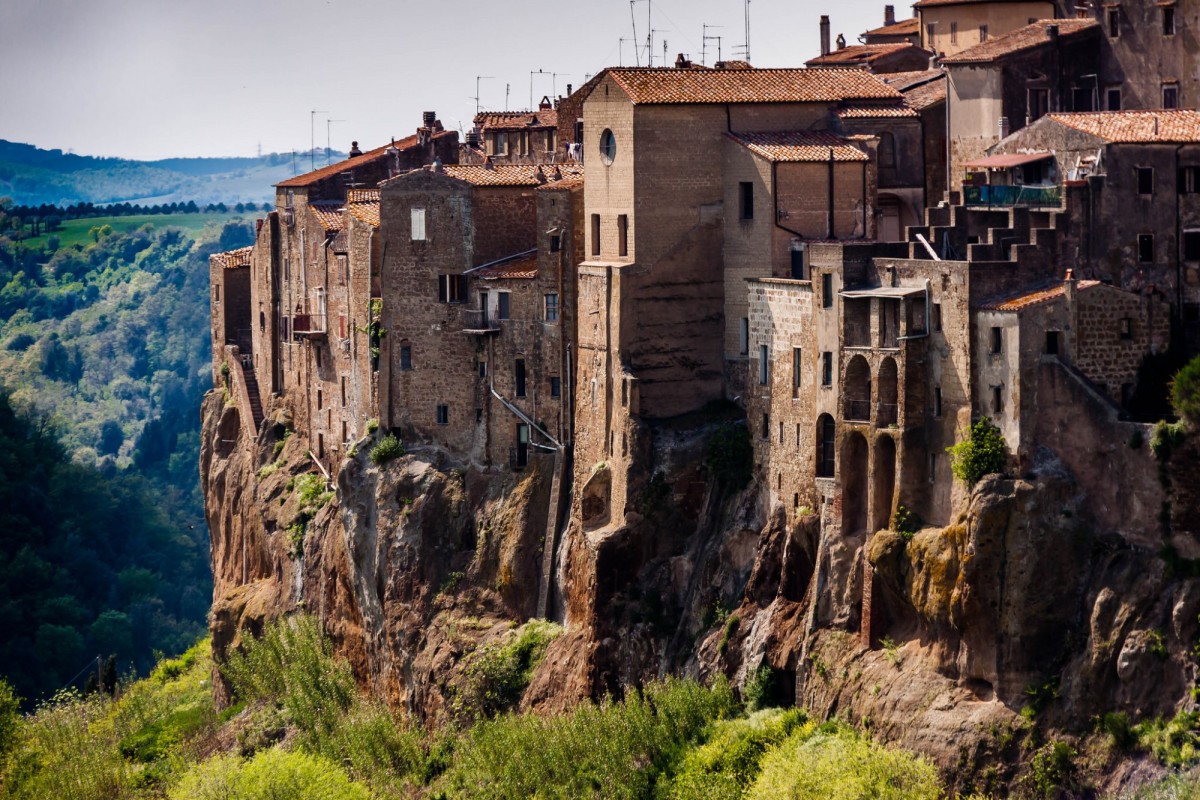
left=0, top=139, right=346, bottom=205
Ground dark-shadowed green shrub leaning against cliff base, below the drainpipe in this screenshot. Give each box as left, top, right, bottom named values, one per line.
left=454, top=620, right=563, bottom=720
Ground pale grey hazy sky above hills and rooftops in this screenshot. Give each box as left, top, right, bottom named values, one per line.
left=0, top=0, right=897, bottom=158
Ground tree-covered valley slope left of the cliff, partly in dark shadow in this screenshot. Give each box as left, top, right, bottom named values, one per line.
left=0, top=203, right=244, bottom=699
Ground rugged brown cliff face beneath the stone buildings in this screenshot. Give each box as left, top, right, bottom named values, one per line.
left=202, top=393, right=1200, bottom=790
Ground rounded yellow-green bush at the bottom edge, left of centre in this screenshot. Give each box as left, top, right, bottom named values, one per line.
left=169, top=747, right=370, bottom=800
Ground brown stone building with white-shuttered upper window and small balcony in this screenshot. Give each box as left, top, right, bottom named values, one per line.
left=379, top=164, right=582, bottom=467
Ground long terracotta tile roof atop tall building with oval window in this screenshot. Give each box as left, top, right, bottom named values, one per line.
left=607, top=67, right=900, bottom=104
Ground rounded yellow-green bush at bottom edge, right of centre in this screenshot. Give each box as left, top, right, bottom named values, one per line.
left=745, top=724, right=942, bottom=800
